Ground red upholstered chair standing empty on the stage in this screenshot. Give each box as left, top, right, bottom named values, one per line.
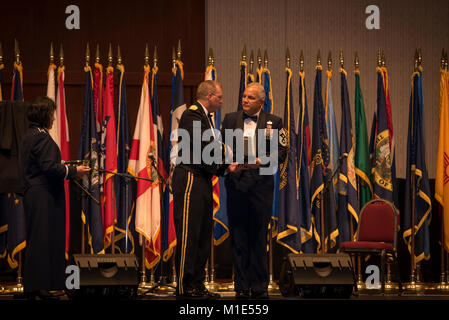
left=339, top=199, right=402, bottom=294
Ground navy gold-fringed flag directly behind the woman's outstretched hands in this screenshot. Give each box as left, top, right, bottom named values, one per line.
left=79, top=67, right=104, bottom=253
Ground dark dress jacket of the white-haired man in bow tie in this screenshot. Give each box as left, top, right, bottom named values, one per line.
left=221, top=109, right=288, bottom=191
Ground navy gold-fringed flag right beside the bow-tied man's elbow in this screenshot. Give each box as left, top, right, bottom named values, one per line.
left=277, top=68, right=302, bottom=253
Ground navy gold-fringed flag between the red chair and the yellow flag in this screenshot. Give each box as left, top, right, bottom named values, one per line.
left=403, top=72, right=432, bottom=263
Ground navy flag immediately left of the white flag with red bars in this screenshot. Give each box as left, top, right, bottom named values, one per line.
left=114, top=64, right=134, bottom=253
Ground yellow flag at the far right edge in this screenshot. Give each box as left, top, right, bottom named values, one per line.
left=435, top=69, right=449, bottom=250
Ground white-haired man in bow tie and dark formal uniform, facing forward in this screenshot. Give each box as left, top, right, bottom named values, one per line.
left=222, top=83, right=288, bottom=299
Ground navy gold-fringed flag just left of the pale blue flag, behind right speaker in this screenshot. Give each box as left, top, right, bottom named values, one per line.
left=310, top=65, right=338, bottom=252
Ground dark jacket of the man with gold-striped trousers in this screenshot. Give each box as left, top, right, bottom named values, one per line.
left=174, top=102, right=226, bottom=179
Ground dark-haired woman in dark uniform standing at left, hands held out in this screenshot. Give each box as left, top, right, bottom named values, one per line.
left=20, top=97, right=90, bottom=298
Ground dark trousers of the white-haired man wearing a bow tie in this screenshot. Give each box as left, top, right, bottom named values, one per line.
left=225, top=170, right=274, bottom=292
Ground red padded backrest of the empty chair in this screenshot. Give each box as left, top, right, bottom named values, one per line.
left=357, top=199, right=398, bottom=249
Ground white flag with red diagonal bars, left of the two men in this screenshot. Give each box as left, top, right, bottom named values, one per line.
left=128, top=66, right=161, bottom=269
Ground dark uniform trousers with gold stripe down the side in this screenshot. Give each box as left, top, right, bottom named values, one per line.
left=172, top=166, right=213, bottom=294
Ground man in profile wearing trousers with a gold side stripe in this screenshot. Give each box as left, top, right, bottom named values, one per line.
left=171, top=80, right=237, bottom=299
